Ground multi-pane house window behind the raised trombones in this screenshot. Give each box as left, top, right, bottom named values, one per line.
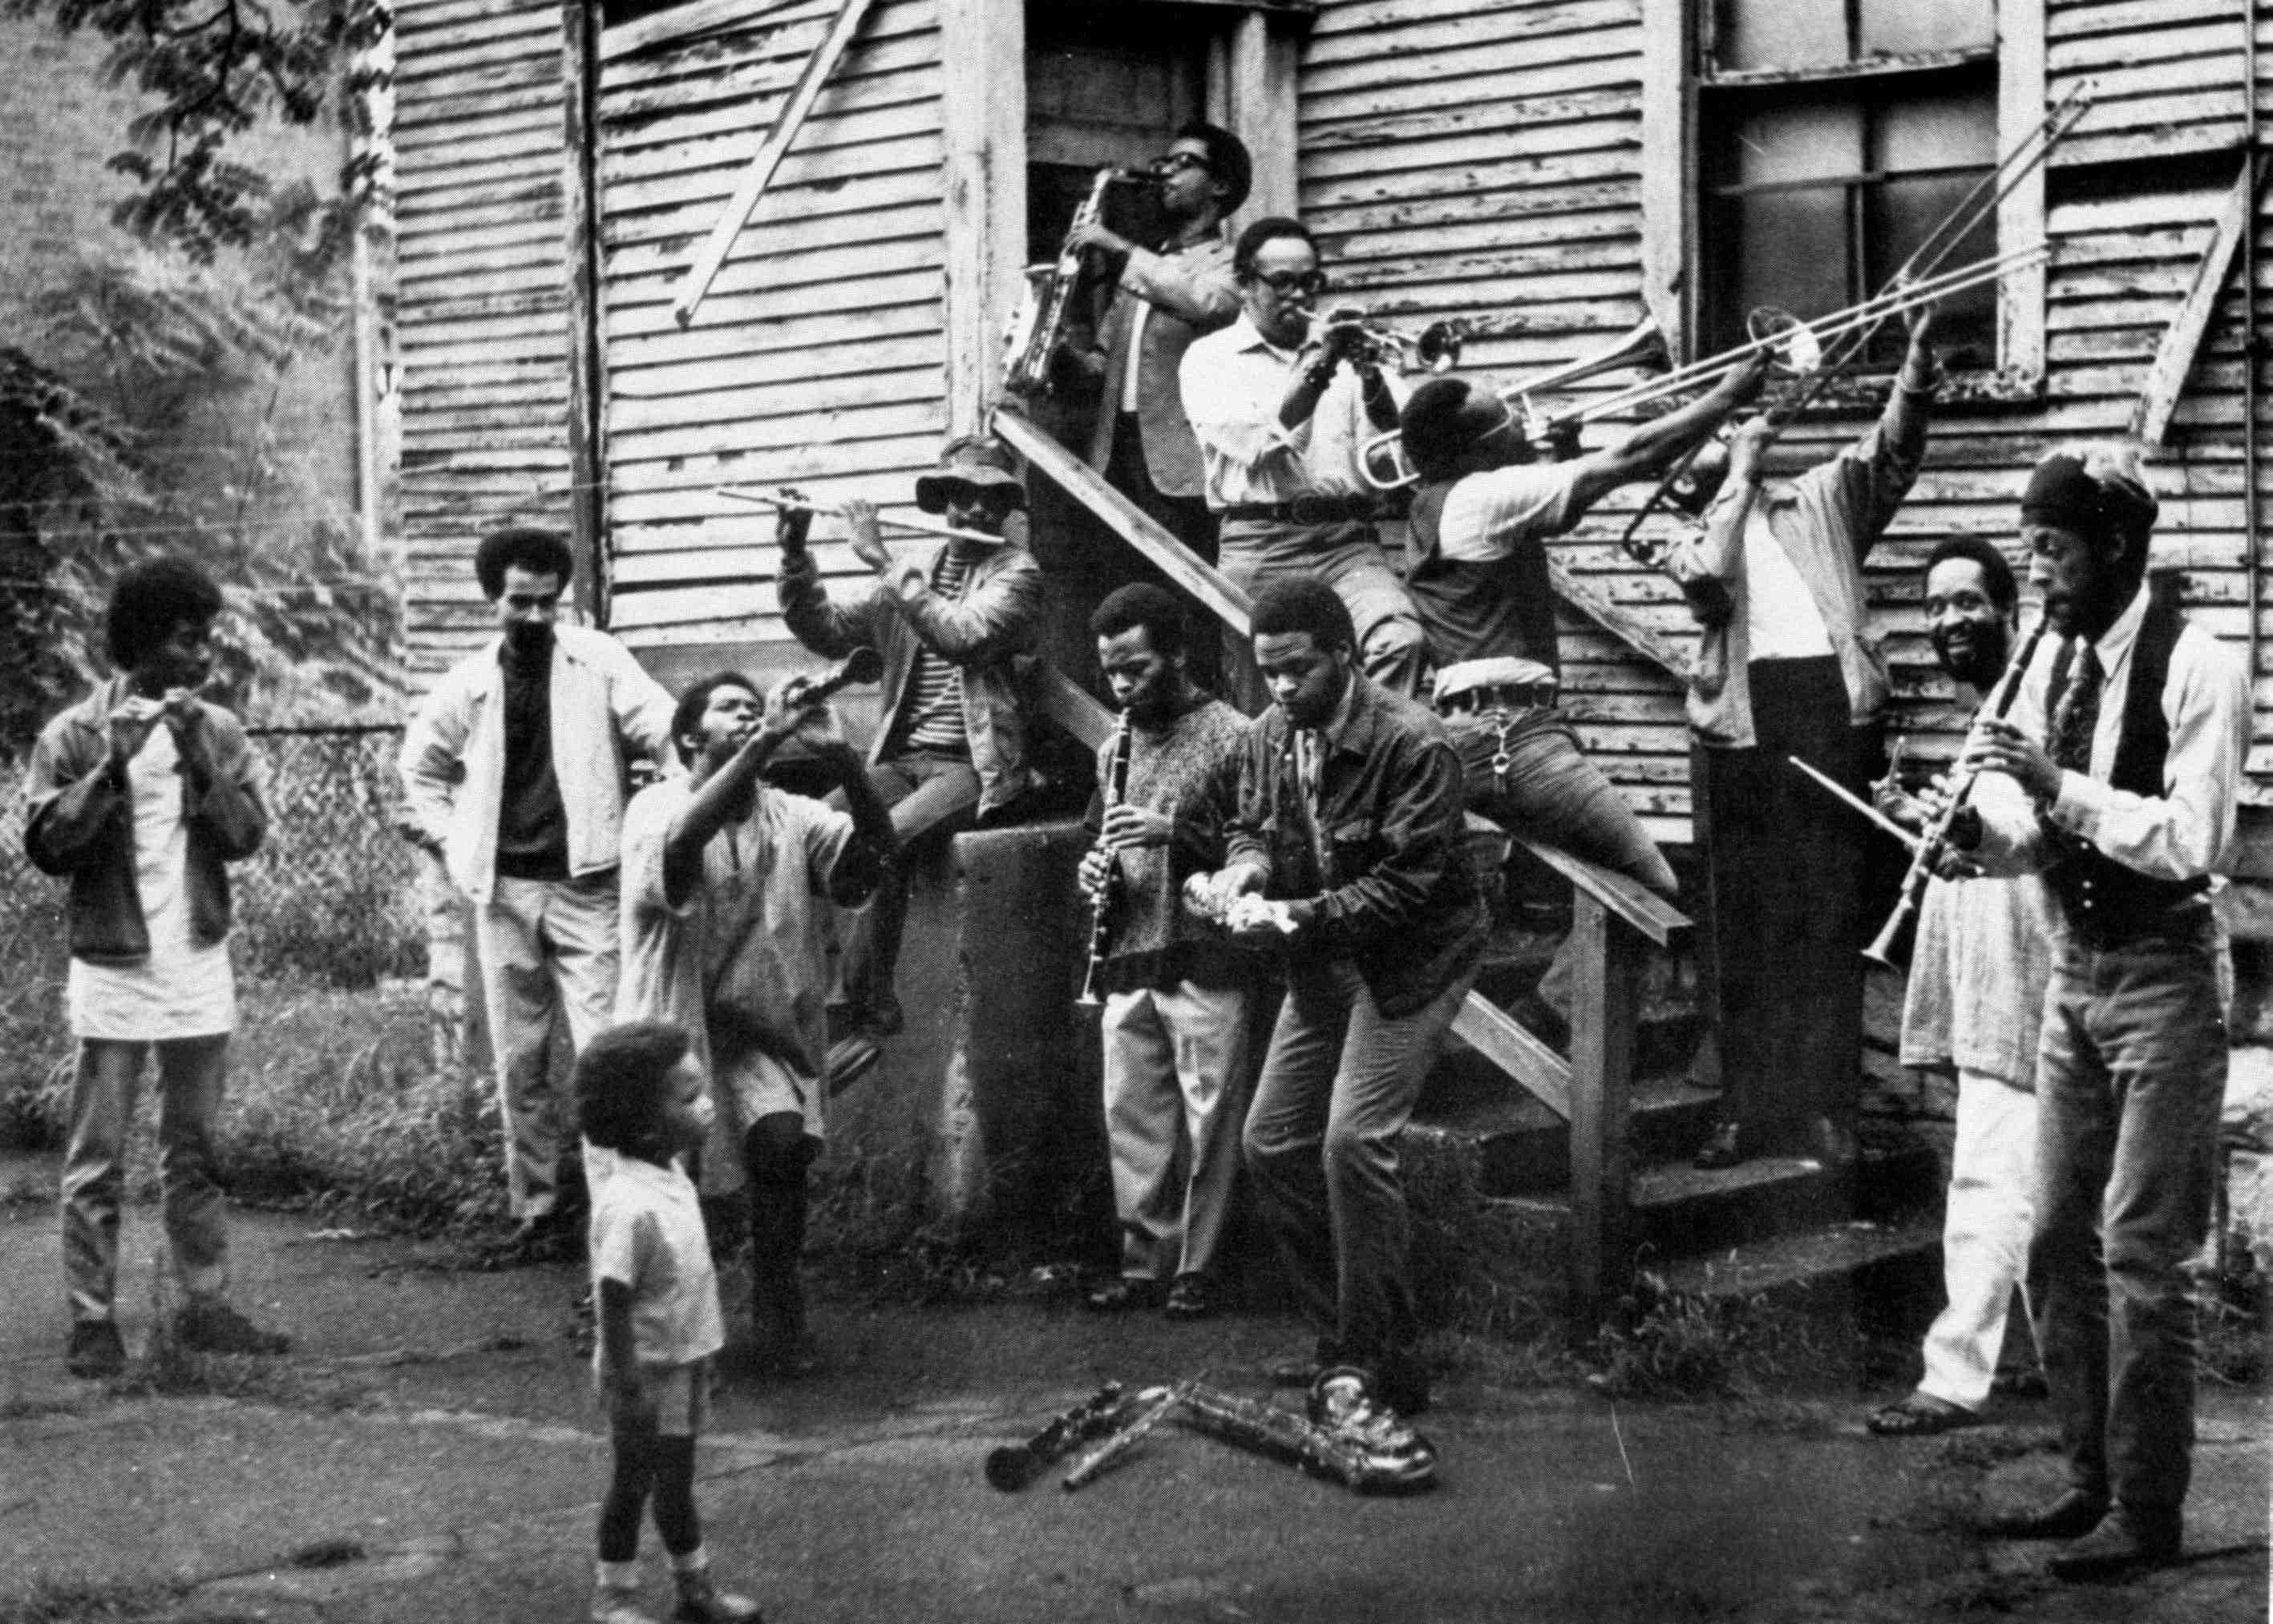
left=1698, top=0, right=1998, bottom=368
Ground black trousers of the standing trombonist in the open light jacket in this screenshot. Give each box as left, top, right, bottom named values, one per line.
left=1689, top=656, right=1887, bottom=1156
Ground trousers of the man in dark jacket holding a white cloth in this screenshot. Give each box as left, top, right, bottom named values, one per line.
left=1241, top=959, right=1475, bottom=1374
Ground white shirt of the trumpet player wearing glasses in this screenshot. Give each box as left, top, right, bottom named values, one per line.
left=1178, top=311, right=1402, bottom=511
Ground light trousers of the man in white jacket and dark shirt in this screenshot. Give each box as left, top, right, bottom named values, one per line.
left=473, top=867, right=616, bottom=1218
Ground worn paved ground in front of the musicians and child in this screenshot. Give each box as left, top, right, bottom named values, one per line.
left=0, top=1165, right=2273, bottom=1624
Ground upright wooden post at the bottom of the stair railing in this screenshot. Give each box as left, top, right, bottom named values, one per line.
left=1566, top=891, right=1641, bottom=1335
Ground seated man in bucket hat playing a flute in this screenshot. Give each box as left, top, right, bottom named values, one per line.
left=775, top=436, right=1041, bottom=1038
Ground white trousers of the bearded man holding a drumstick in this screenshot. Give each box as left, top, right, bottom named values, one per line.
left=1919, top=1065, right=2036, bottom=1411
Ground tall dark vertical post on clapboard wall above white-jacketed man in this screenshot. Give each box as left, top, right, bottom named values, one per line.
left=561, top=0, right=607, bottom=627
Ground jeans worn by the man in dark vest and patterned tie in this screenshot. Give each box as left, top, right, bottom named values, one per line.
left=2028, top=911, right=2225, bottom=1513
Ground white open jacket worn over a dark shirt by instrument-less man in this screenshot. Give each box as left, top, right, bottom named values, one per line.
left=400, top=627, right=675, bottom=902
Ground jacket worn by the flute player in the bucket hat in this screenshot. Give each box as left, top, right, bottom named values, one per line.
left=775, top=543, right=1041, bottom=815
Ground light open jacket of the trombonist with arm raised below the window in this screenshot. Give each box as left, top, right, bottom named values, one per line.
left=1666, top=384, right=1930, bottom=749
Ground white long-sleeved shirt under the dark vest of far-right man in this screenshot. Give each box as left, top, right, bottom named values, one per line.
left=1973, top=586, right=2251, bottom=879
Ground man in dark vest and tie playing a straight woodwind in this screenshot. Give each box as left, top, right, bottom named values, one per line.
left=1952, top=445, right=2251, bottom=1578
